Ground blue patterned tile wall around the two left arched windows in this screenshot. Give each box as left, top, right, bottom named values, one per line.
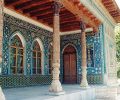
left=2, top=14, right=52, bottom=75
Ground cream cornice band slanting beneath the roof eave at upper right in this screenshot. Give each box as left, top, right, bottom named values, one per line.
left=80, top=0, right=116, bottom=26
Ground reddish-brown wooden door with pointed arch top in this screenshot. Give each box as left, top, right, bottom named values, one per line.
left=63, top=45, right=77, bottom=84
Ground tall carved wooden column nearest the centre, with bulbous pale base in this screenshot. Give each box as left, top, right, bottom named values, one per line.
left=49, top=0, right=63, bottom=95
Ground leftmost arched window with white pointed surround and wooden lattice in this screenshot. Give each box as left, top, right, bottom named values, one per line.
left=9, top=31, right=25, bottom=74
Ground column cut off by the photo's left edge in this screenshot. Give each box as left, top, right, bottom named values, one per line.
left=0, top=0, right=5, bottom=100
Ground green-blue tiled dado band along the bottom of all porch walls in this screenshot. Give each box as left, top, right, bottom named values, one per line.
left=0, top=74, right=102, bottom=88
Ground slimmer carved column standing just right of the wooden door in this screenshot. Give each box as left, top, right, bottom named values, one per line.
left=80, top=21, right=88, bottom=87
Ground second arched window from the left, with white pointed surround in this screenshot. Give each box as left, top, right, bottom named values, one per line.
left=31, top=38, right=44, bottom=74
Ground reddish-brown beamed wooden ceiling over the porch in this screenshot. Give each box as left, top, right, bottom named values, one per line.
left=4, top=0, right=100, bottom=32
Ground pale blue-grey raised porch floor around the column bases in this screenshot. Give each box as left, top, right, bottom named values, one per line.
left=3, top=85, right=95, bottom=100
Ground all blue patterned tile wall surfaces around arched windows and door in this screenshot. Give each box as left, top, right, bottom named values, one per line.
left=2, top=14, right=106, bottom=83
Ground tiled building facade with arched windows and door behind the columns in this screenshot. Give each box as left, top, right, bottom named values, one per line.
left=0, top=0, right=117, bottom=92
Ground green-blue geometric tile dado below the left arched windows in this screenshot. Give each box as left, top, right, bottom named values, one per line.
left=0, top=75, right=52, bottom=88
